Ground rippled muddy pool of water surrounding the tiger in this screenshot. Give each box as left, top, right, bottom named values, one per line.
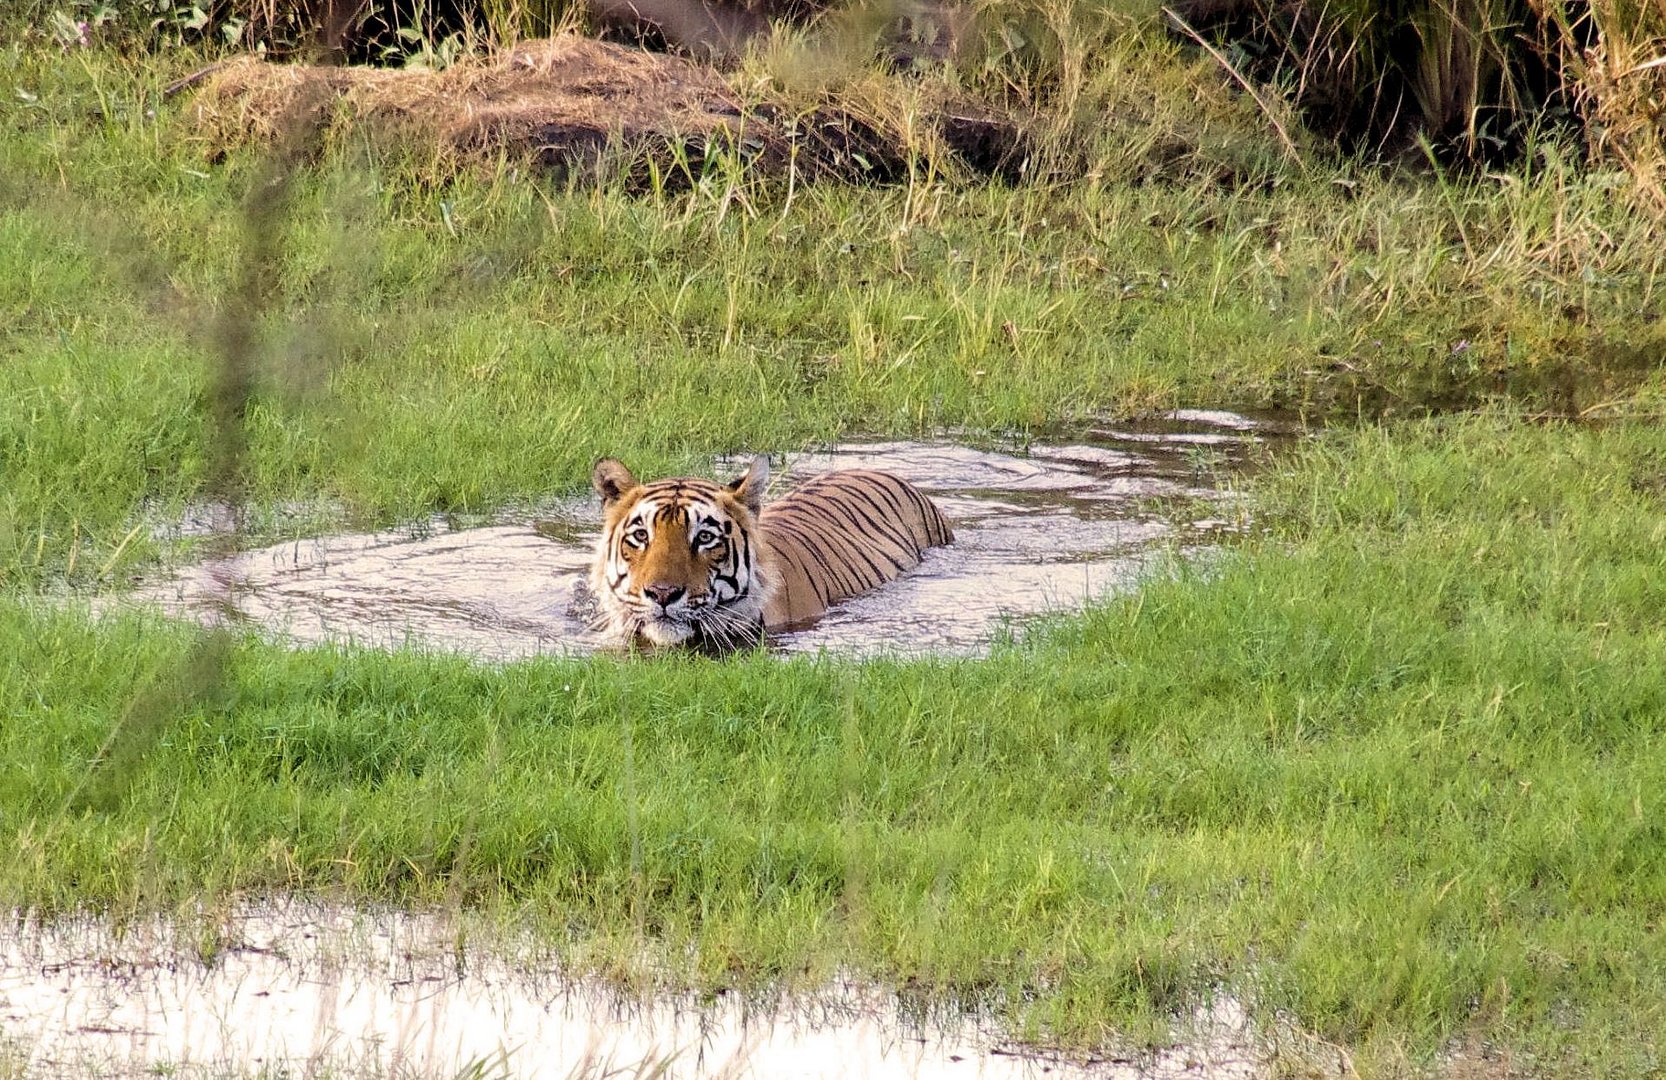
left=129, top=412, right=1288, bottom=658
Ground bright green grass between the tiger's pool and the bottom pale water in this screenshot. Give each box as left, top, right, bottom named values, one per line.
left=0, top=411, right=1666, bottom=1075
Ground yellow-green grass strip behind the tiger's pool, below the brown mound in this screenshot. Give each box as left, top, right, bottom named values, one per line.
left=0, top=47, right=1666, bottom=583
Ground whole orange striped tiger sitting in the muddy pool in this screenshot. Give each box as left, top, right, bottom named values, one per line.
left=590, top=457, right=955, bottom=653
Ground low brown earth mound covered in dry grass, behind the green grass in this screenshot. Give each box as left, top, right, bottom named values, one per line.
left=190, top=35, right=1030, bottom=187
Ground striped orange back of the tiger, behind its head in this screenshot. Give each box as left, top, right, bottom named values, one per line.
left=758, top=468, right=955, bottom=630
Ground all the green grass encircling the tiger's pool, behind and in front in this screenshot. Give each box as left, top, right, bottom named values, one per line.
left=0, top=6, right=1666, bottom=1077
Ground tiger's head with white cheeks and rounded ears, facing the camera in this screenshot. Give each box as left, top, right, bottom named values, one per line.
left=591, top=457, right=770, bottom=650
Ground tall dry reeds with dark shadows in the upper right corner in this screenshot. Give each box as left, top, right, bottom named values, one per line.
left=1165, top=0, right=1666, bottom=205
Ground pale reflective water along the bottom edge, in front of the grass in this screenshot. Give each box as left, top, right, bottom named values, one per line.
left=0, top=902, right=1281, bottom=1080
